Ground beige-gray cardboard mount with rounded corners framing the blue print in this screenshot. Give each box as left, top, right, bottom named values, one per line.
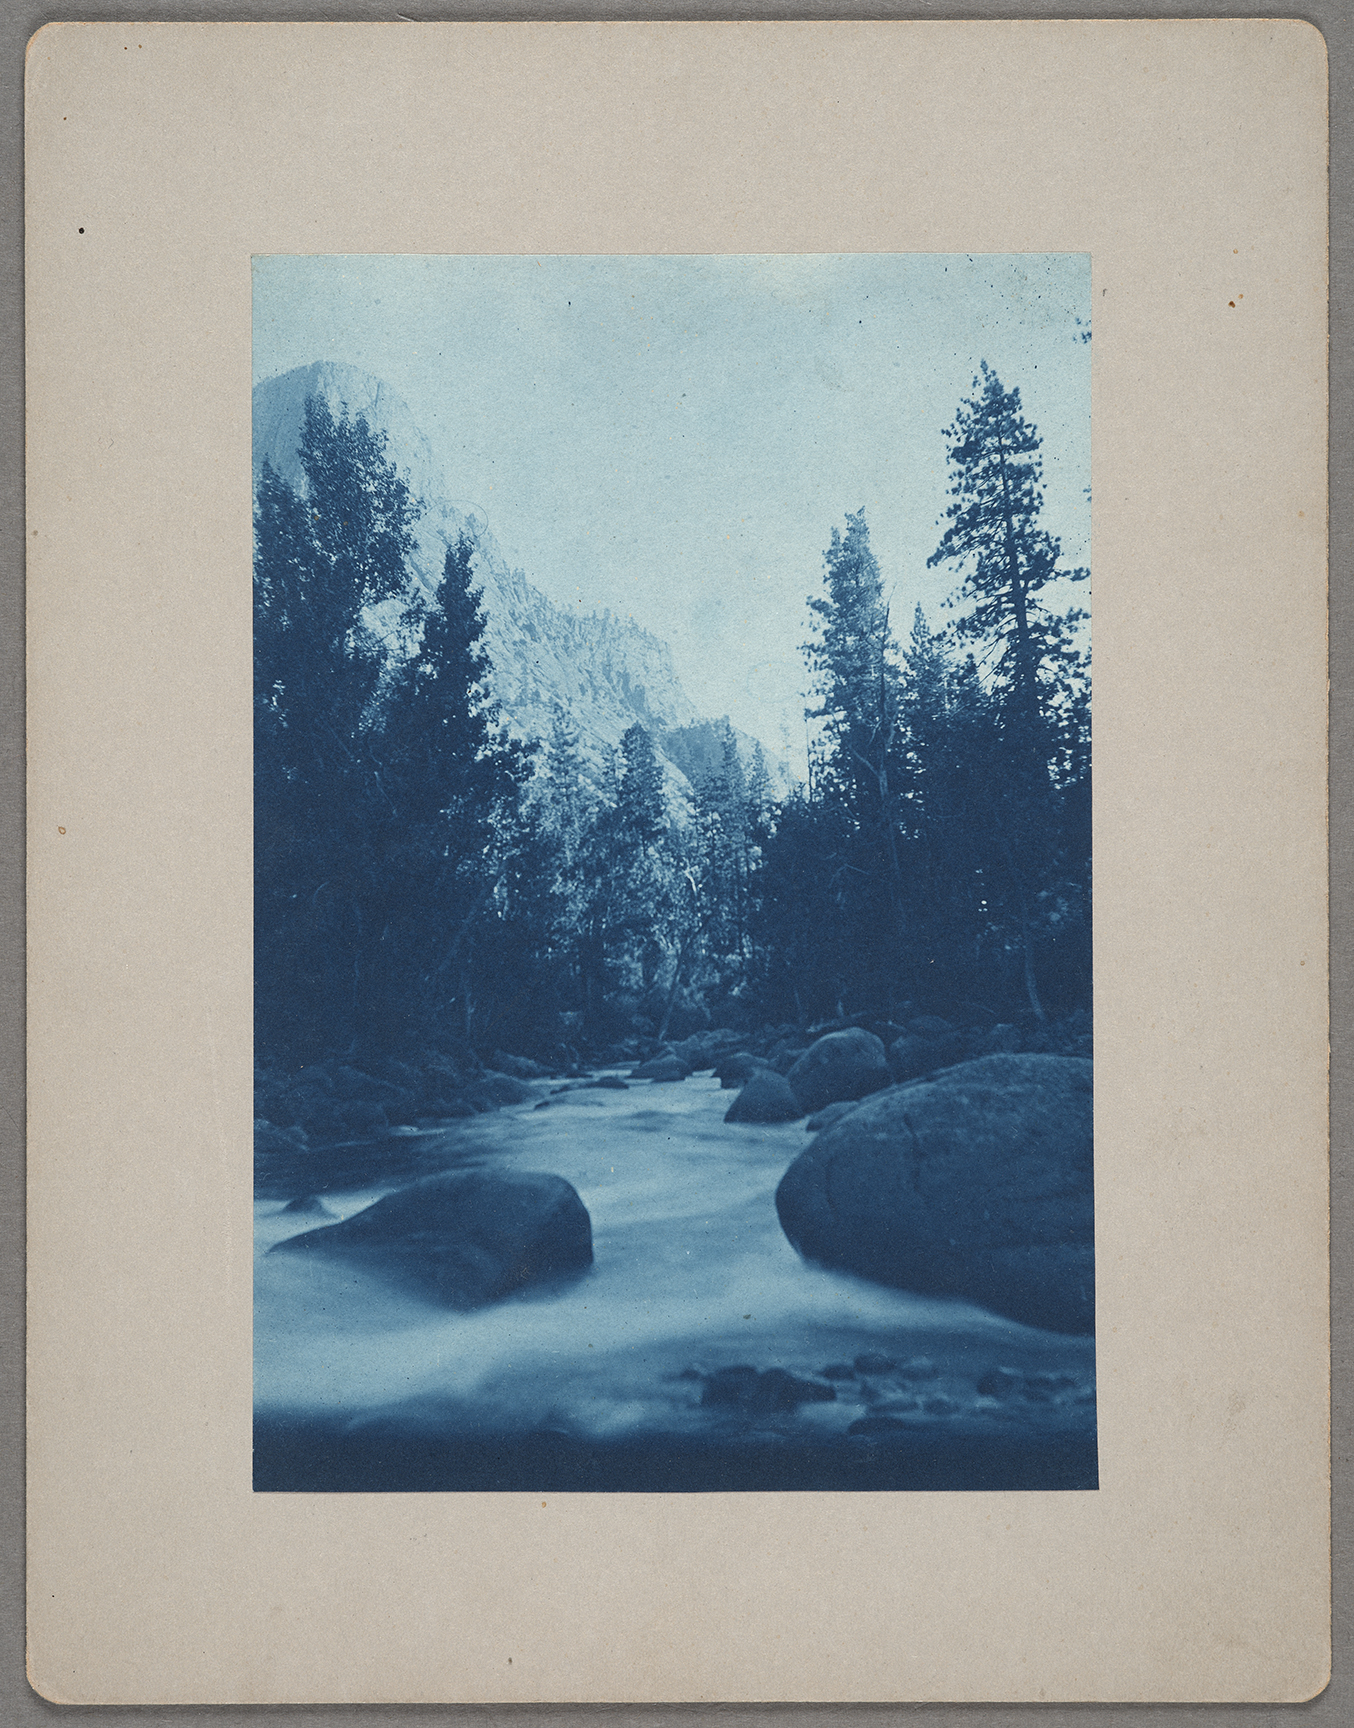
left=26, top=21, right=1330, bottom=1704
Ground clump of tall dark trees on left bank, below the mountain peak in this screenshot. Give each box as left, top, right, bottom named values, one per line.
left=254, top=397, right=525, bottom=1056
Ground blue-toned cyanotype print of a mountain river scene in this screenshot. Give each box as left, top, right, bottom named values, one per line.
left=252, top=254, right=1098, bottom=1493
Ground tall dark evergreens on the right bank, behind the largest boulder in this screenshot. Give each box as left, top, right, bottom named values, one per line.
left=762, top=365, right=1090, bottom=1023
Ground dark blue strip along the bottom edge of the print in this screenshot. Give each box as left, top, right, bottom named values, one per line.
left=254, top=1417, right=1098, bottom=1493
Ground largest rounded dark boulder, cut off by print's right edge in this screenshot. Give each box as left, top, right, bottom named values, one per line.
left=775, top=1056, right=1095, bottom=1332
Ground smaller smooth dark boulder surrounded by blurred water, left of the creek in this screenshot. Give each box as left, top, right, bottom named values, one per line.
left=273, top=1170, right=592, bottom=1308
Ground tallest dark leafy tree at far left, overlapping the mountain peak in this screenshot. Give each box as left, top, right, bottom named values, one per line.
left=254, top=397, right=420, bottom=1054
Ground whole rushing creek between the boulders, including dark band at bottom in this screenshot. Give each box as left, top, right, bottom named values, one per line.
left=254, top=1075, right=1095, bottom=1490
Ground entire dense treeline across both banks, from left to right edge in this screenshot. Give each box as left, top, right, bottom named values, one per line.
left=254, top=366, right=1090, bottom=1064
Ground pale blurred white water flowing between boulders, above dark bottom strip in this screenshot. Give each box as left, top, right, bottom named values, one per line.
left=254, top=1075, right=1093, bottom=1436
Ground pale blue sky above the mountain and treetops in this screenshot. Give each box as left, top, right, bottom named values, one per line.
left=254, top=254, right=1091, bottom=769
